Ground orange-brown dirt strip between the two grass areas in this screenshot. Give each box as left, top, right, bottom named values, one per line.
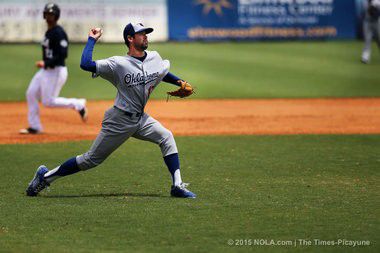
left=0, top=98, right=380, bottom=144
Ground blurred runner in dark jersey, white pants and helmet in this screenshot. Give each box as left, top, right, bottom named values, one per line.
left=20, top=3, right=87, bottom=134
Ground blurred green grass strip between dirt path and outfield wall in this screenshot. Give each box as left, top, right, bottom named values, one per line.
left=0, top=41, right=380, bottom=101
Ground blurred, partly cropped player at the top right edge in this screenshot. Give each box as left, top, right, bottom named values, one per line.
left=361, top=0, right=380, bottom=64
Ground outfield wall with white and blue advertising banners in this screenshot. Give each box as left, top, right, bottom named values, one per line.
left=0, top=0, right=363, bottom=42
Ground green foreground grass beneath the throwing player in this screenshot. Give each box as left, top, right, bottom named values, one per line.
left=0, top=135, right=380, bottom=252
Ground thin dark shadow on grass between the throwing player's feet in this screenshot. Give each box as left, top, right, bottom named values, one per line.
left=40, top=192, right=169, bottom=198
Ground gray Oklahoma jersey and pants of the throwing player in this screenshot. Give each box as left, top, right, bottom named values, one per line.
left=76, top=51, right=178, bottom=170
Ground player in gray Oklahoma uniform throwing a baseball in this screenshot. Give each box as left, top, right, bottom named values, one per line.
left=26, top=23, right=196, bottom=198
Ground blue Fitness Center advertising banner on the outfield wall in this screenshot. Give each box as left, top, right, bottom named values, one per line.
left=168, top=0, right=357, bottom=40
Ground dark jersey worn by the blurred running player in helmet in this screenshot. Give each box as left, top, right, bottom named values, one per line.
left=42, top=25, right=69, bottom=68
